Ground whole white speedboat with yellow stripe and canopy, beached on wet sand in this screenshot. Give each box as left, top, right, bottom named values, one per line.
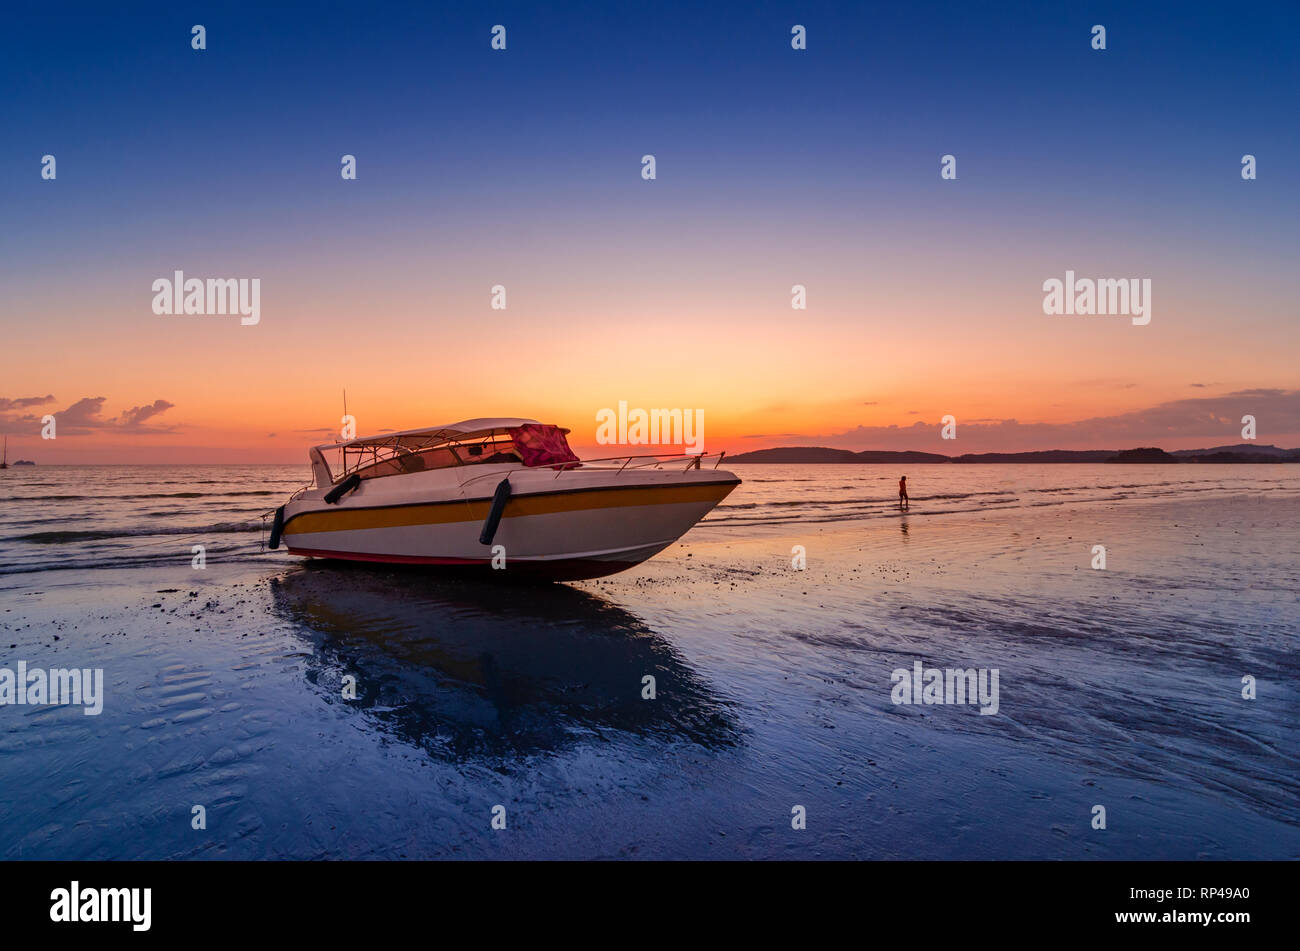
left=270, top=418, right=740, bottom=581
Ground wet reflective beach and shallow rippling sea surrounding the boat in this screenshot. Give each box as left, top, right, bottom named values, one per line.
left=0, top=465, right=1300, bottom=859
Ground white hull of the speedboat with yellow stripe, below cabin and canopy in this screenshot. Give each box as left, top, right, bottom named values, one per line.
left=282, top=470, right=740, bottom=581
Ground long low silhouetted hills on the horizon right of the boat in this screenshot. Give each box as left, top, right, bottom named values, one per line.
left=727, top=443, right=1300, bottom=465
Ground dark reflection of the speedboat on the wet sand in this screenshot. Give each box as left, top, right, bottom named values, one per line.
left=272, top=563, right=740, bottom=760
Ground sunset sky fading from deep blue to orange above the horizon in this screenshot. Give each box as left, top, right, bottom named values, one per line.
left=0, top=3, right=1300, bottom=463
